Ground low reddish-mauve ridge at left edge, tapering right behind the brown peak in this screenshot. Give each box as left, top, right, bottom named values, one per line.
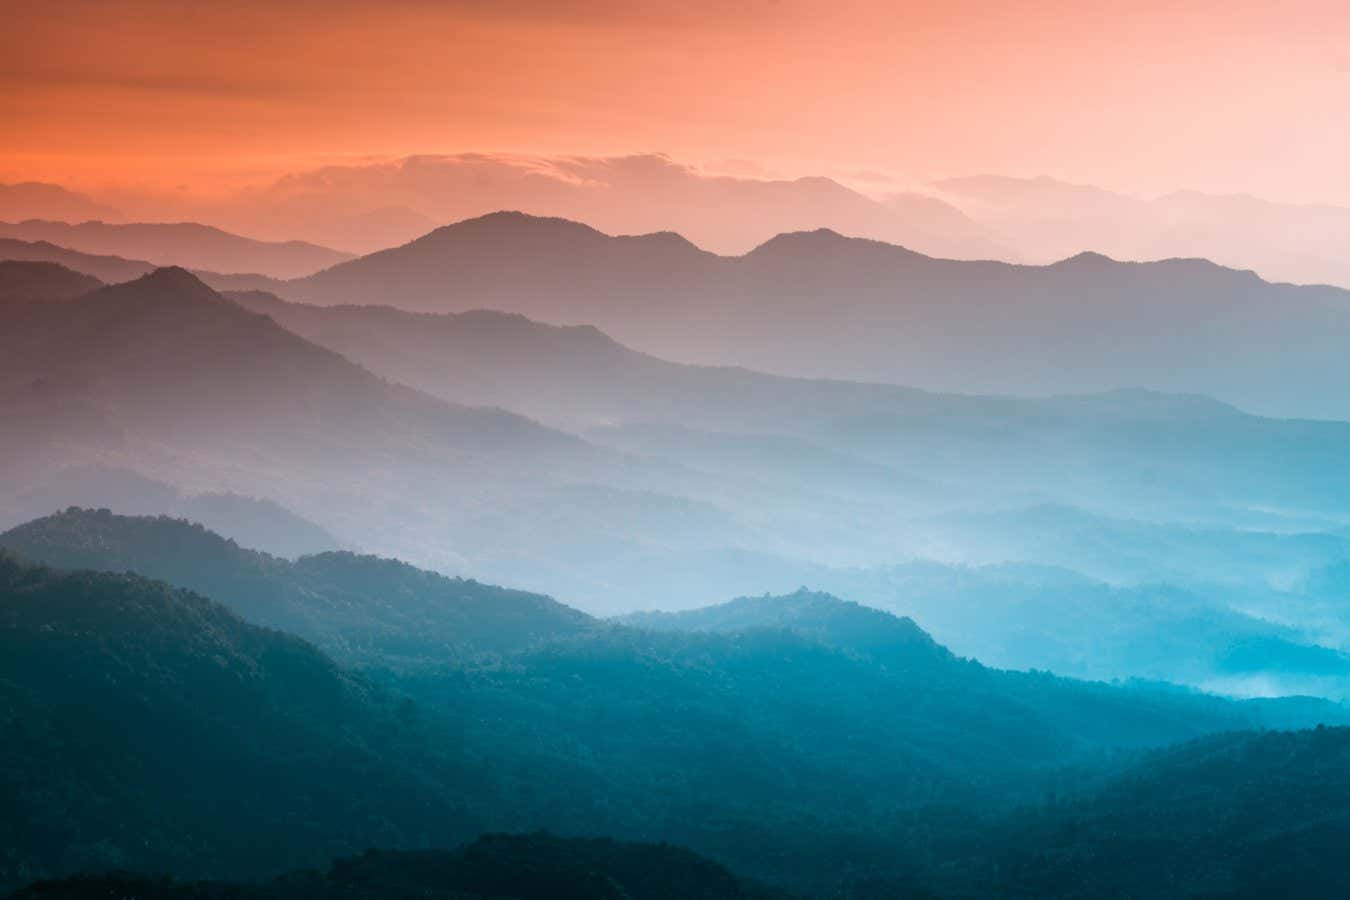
left=0, top=219, right=351, bottom=278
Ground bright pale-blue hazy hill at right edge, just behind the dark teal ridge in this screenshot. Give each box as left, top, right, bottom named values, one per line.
left=784, top=561, right=1350, bottom=698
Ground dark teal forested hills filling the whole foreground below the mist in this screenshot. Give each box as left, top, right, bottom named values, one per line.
left=0, top=510, right=1350, bottom=897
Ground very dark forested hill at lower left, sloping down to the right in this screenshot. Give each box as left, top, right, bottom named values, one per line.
left=0, top=555, right=491, bottom=885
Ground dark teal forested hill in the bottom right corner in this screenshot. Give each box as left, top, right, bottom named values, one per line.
left=953, top=729, right=1350, bottom=900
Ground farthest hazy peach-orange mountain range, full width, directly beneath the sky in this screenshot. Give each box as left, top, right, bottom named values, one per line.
left=21, top=152, right=1350, bottom=287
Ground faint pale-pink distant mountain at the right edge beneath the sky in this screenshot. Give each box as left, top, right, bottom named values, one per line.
left=932, top=175, right=1350, bottom=287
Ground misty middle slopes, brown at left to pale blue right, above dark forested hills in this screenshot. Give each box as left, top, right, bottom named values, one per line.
left=0, top=260, right=1350, bottom=696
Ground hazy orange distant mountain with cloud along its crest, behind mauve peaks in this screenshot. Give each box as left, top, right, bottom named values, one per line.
left=231, top=152, right=1013, bottom=259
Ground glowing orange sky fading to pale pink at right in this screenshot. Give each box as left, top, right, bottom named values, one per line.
left=0, top=0, right=1350, bottom=204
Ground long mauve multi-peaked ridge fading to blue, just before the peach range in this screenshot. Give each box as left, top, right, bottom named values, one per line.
left=281, top=213, right=1350, bottom=418
